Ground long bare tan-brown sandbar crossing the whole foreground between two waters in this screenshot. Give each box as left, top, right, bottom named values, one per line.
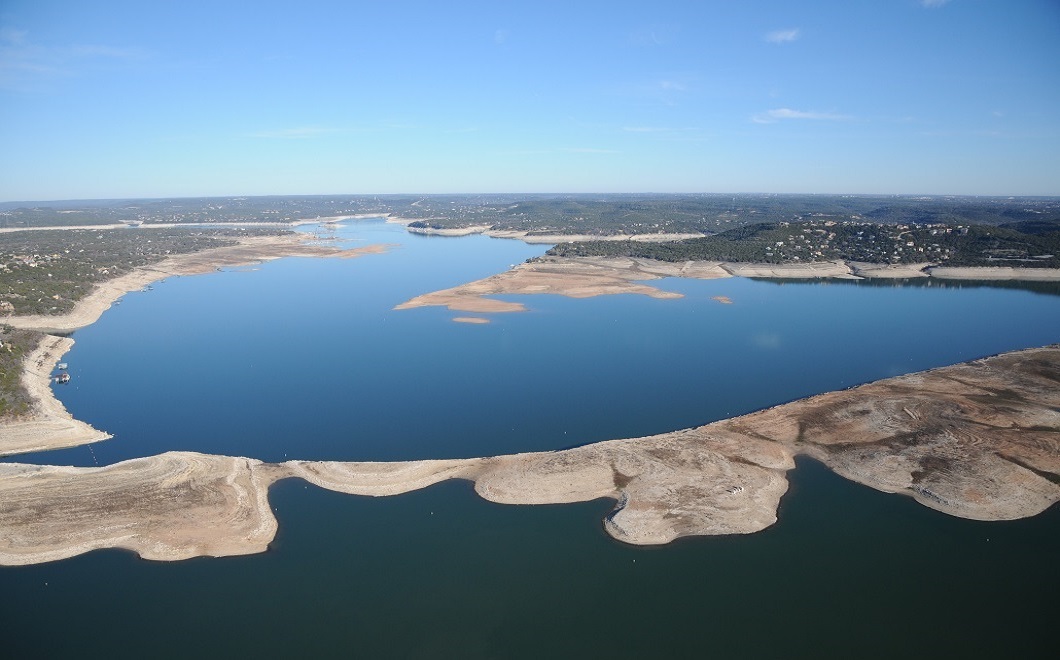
left=0, top=345, right=1060, bottom=565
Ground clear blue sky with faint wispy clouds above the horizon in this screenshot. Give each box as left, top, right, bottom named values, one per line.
left=0, top=0, right=1060, bottom=201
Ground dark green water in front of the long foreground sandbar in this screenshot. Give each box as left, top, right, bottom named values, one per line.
left=0, top=459, right=1060, bottom=658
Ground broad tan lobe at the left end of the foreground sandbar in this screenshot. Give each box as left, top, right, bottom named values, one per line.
left=0, top=452, right=277, bottom=566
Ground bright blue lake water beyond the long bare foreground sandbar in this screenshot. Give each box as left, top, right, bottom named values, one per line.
left=19, top=217, right=1060, bottom=465
